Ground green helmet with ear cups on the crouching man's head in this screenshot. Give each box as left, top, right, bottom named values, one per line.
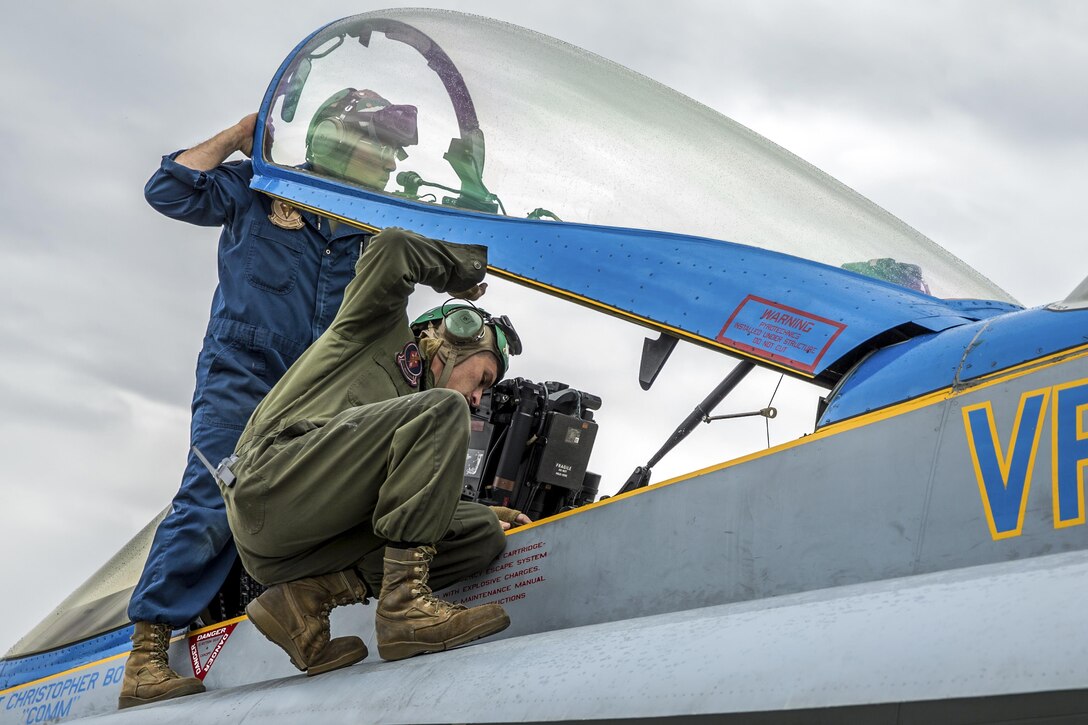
left=411, top=302, right=521, bottom=388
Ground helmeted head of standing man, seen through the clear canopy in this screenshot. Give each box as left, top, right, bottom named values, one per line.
left=306, top=88, right=419, bottom=187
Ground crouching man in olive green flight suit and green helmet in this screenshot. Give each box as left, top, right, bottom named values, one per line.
left=221, top=229, right=529, bottom=675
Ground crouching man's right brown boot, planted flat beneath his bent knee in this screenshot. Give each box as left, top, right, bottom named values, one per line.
left=374, top=546, right=510, bottom=660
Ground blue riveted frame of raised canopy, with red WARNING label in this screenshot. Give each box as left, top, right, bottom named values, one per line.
left=252, top=174, right=1018, bottom=382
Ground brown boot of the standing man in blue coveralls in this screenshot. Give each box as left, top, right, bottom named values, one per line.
left=118, top=622, right=205, bottom=710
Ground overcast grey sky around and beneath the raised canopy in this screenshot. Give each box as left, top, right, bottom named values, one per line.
left=0, top=0, right=1088, bottom=650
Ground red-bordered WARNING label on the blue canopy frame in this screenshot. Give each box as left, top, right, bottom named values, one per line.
left=717, top=295, right=846, bottom=372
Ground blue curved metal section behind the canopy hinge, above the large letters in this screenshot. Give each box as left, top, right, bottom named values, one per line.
left=817, top=307, right=1088, bottom=428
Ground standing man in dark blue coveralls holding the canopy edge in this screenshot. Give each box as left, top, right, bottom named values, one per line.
left=119, top=88, right=418, bottom=708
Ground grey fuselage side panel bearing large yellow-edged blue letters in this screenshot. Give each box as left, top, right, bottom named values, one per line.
left=435, top=348, right=1088, bottom=618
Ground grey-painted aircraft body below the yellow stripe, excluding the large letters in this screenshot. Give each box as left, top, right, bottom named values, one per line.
left=0, top=348, right=1088, bottom=723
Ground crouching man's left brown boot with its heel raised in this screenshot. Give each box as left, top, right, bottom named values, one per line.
left=246, top=570, right=367, bottom=675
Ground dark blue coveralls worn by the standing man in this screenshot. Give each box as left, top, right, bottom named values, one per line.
left=128, top=151, right=370, bottom=627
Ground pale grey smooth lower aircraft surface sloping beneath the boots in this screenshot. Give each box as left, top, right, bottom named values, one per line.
left=34, top=552, right=1088, bottom=723
